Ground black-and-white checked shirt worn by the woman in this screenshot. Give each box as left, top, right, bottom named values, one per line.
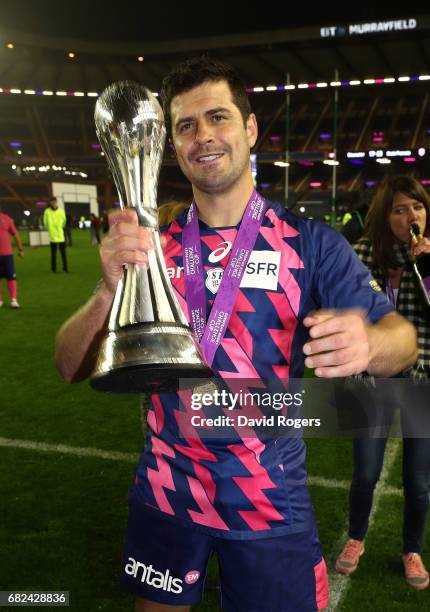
left=353, top=238, right=430, bottom=379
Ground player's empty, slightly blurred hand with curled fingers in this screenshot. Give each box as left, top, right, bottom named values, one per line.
left=303, top=310, right=370, bottom=378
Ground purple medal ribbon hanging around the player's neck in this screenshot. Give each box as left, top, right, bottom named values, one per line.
left=182, top=189, right=267, bottom=366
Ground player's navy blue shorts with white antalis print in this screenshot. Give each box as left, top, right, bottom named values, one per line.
left=121, top=492, right=328, bottom=612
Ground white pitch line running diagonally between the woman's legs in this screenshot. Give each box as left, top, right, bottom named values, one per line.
left=328, top=438, right=400, bottom=612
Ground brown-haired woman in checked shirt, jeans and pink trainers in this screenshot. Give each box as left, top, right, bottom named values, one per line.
left=336, top=176, right=430, bottom=590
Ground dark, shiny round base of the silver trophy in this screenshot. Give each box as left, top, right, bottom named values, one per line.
left=90, top=323, right=213, bottom=393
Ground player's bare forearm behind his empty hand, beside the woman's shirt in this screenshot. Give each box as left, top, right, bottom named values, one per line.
left=367, top=312, right=417, bottom=376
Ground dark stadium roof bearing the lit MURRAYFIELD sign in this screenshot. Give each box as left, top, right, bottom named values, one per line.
left=0, top=0, right=430, bottom=92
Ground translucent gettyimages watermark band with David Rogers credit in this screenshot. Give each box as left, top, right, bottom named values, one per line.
left=175, top=376, right=430, bottom=439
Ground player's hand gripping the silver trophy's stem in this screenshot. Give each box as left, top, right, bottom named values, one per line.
left=100, top=208, right=154, bottom=294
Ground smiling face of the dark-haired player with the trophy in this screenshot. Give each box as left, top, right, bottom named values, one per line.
left=170, top=81, right=257, bottom=193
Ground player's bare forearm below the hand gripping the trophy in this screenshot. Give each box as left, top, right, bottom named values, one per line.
left=55, top=285, right=113, bottom=383
